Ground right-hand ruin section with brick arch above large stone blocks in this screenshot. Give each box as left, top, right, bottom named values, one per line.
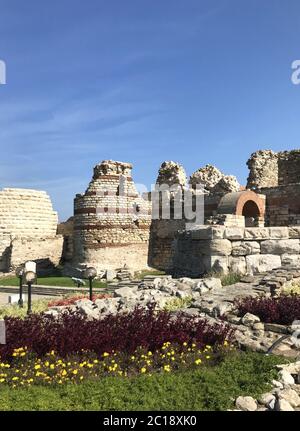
left=172, top=150, right=300, bottom=276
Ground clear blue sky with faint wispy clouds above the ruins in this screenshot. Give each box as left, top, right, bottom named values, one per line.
left=0, top=0, right=300, bottom=220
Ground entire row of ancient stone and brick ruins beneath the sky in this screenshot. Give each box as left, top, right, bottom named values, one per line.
left=0, top=150, right=300, bottom=277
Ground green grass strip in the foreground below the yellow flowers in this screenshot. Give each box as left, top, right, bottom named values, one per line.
left=0, top=352, right=284, bottom=411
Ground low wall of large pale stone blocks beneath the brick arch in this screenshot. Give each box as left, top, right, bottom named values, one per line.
left=173, top=226, right=300, bottom=277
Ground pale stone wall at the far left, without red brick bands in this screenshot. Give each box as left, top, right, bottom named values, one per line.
left=0, top=188, right=63, bottom=272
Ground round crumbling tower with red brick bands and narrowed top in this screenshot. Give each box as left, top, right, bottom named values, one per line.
left=73, top=160, right=151, bottom=270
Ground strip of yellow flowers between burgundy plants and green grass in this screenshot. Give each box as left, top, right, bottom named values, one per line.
left=0, top=341, right=231, bottom=387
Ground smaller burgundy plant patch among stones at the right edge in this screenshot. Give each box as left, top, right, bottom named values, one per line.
left=235, top=294, right=300, bottom=325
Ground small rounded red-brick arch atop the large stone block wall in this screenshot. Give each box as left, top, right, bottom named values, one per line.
left=218, top=190, right=265, bottom=218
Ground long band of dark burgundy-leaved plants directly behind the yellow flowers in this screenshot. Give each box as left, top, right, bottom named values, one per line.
left=0, top=307, right=233, bottom=360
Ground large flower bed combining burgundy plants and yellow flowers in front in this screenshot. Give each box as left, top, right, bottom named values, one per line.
left=0, top=307, right=233, bottom=386
